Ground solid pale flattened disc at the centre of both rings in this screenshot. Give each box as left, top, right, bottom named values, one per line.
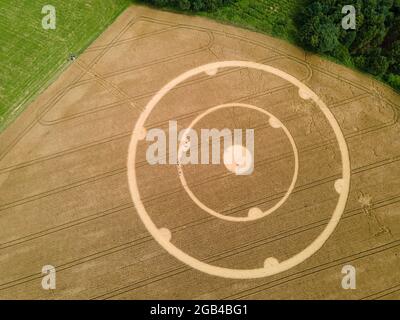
left=224, top=144, right=253, bottom=175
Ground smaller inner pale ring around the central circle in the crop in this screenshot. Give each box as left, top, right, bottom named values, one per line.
left=178, top=103, right=299, bottom=222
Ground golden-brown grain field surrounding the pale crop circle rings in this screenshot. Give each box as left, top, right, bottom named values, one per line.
left=0, top=6, right=400, bottom=299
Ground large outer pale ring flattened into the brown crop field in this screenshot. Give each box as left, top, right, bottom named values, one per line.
left=127, top=61, right=351, bottom=279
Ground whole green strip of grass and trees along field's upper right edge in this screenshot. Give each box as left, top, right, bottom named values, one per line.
left=142, top=0, right=400, bottom=90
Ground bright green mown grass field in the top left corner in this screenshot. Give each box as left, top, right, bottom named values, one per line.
left=0, top=0, right=131, bottom=131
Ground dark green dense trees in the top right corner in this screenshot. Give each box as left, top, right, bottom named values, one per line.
left=297, top=0, right=400, bottom=90
